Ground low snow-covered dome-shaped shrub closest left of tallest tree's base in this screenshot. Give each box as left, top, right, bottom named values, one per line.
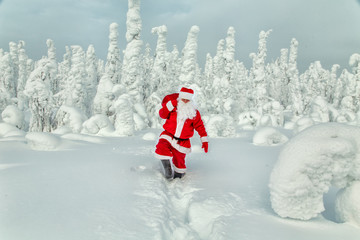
left=82, top=114, right=115, bottom=136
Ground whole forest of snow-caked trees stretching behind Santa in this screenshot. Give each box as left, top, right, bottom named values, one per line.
left=0, top=1, right=360, bottom=137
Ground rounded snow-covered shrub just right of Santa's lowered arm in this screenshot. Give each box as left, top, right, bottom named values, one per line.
left=205, top=114, right=235, bottom=137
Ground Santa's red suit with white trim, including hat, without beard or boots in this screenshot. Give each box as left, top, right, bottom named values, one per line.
left=155, top=88, right=208, bottom=173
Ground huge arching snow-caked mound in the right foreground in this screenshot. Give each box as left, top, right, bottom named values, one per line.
left=269, top=123, right=360, bottom=220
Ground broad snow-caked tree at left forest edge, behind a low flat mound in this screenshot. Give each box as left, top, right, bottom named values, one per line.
left=24, top=58, right=53, bottom=132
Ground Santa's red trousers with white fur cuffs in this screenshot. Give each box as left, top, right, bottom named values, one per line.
left=155, top=138, right=186, bottom=173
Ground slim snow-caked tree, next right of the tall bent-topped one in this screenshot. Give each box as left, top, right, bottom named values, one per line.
left=286, top=38, right=304, bottom=116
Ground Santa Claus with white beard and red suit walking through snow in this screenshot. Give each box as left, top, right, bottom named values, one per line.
left=155, top=87, right=208, bottom=179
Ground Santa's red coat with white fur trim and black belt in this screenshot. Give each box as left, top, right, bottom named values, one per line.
left=159, top=93, right=208, bottom=153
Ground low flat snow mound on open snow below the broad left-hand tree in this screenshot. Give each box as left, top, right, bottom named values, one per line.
left=25, top=132, right=61, bottom=151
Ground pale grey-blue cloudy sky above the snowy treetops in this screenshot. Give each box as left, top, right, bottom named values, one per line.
left=0, top=0, right=360, bottom=72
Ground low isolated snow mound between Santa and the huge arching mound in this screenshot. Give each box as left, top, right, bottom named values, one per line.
left=253, top=127, right=289, bottom=146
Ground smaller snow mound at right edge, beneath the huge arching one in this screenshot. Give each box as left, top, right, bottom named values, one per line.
left=335, top=181, right=360, bottom=227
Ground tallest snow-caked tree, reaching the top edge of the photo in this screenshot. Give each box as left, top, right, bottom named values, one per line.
left=121, top=0, right=148, bottom=130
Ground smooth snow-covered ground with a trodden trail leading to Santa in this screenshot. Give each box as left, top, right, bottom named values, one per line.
left=0, top=126, right=360, bottom=240
